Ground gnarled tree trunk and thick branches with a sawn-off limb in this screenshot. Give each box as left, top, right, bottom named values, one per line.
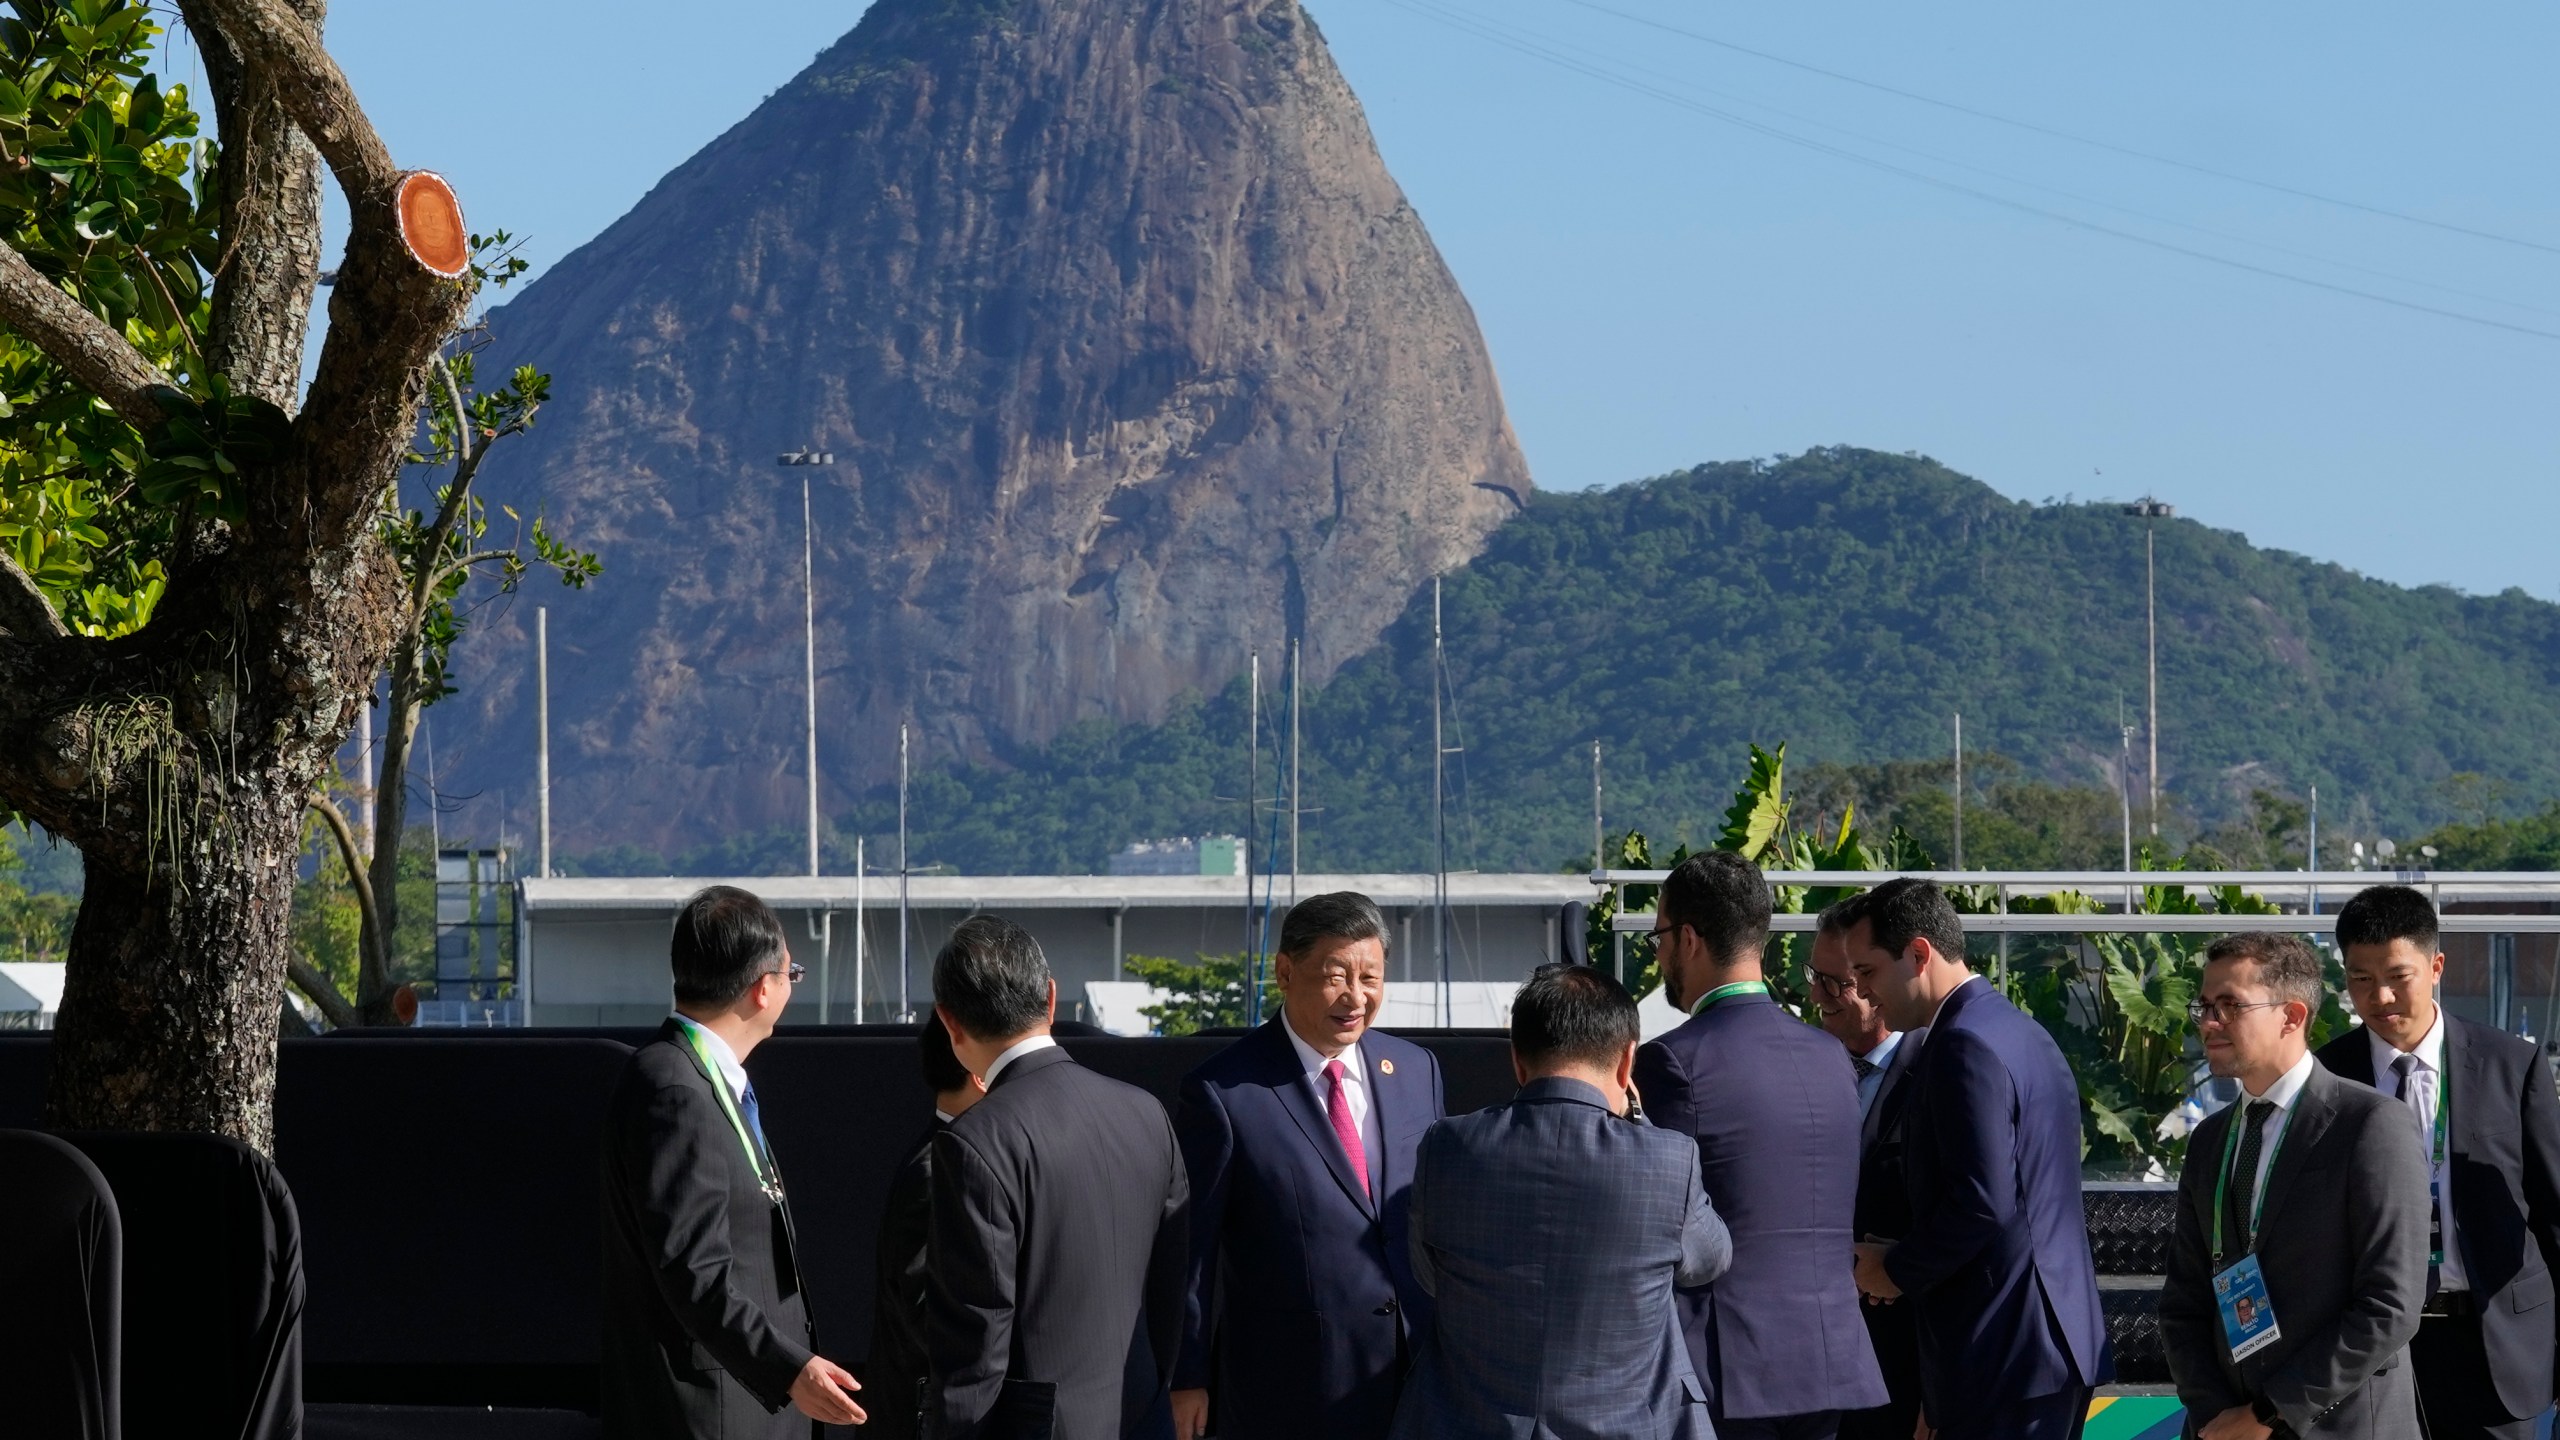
left=0, top=0, right=468, bottom=1148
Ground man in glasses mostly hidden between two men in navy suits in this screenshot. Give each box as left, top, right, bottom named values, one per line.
left=1805, top=899, right=1928, bottom=1440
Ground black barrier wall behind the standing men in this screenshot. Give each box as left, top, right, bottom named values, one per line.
left=0, top=1027, right=1513, bottom=1407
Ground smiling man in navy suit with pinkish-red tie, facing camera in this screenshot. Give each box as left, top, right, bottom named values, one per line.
left=1172, top=892, right=1441, bottom=1440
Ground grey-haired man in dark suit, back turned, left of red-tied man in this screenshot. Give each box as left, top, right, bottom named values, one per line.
left=924, top=915, right=1190, bottom=1440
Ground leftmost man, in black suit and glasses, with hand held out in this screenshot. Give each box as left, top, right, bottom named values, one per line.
left=602, top=884, right=863, bottom=1440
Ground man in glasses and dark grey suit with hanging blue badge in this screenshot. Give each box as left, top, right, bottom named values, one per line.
left=2160, top=935, right=2427, bottom=1440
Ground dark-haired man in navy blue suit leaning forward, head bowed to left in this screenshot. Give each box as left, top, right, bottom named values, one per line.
left=1848, top=879, right=2109, bottom=1440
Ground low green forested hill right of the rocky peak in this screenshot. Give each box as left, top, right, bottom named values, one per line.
left=586, top=448, right=2560, bottom=874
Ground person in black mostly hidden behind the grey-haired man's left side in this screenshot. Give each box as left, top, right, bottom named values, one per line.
left=863, top=1020, right=986, bottom=1440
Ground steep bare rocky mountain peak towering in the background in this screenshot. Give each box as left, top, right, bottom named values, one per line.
left=433, top=0, right=1528, bottom=851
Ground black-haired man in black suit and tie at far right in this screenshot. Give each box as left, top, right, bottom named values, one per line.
left=2319, top=884, right=2560, bottom=1440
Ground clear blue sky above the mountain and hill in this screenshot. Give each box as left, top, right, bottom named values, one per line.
left=230, top=0, right=2560, bottom=597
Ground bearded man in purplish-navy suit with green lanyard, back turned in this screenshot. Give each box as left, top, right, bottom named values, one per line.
left=1636, top=851, right=1887, bottom=1440
